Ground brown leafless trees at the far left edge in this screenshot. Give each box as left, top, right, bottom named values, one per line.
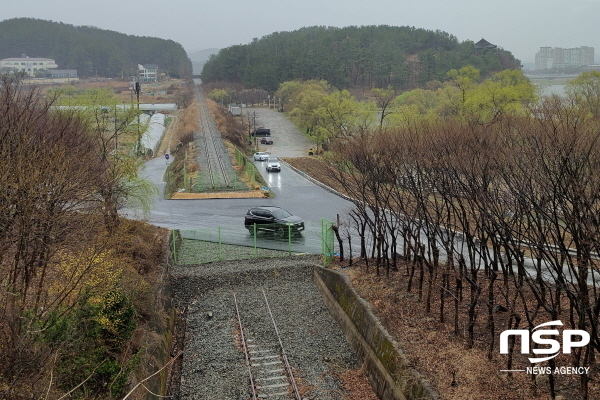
left=0, top=76, right=110, bottom=394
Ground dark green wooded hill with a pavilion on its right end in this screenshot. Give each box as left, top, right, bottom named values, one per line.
left=201, top=25, right=520, bottom=91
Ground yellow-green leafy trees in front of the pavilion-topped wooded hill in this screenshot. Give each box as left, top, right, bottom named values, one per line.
left=260, top=66, right=538, bottom=152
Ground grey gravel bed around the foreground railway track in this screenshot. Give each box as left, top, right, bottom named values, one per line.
left=171, top=256, right=358, bottom=400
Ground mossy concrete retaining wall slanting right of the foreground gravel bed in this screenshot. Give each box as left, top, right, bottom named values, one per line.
left=313, top=266, right=438, bottom=400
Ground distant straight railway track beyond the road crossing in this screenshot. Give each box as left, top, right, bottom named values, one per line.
left=196, top=88, right=235, bottom=190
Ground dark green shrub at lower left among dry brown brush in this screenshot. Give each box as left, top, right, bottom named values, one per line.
left=44, top=288, right=139, bottom=398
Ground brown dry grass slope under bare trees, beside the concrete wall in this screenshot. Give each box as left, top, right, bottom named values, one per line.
left=334, top=264, right=600, bottom=400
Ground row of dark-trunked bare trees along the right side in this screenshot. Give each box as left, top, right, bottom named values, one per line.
left=316, top=70, right=600, bottom=399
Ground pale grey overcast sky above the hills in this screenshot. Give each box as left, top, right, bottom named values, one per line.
left=0, top=0, right=600, bottom=63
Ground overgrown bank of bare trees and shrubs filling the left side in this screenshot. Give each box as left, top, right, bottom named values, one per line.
left=0, top=75, right=167, bottom=399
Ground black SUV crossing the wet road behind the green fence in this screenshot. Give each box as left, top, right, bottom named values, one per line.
left=244, top=206, right=304, bottom=237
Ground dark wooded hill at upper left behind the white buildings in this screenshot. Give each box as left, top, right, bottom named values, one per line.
left=0, top=18, right=192, bottom=78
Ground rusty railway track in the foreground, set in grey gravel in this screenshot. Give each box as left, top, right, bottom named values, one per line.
left=233, top=290, right=303, bottom=400
